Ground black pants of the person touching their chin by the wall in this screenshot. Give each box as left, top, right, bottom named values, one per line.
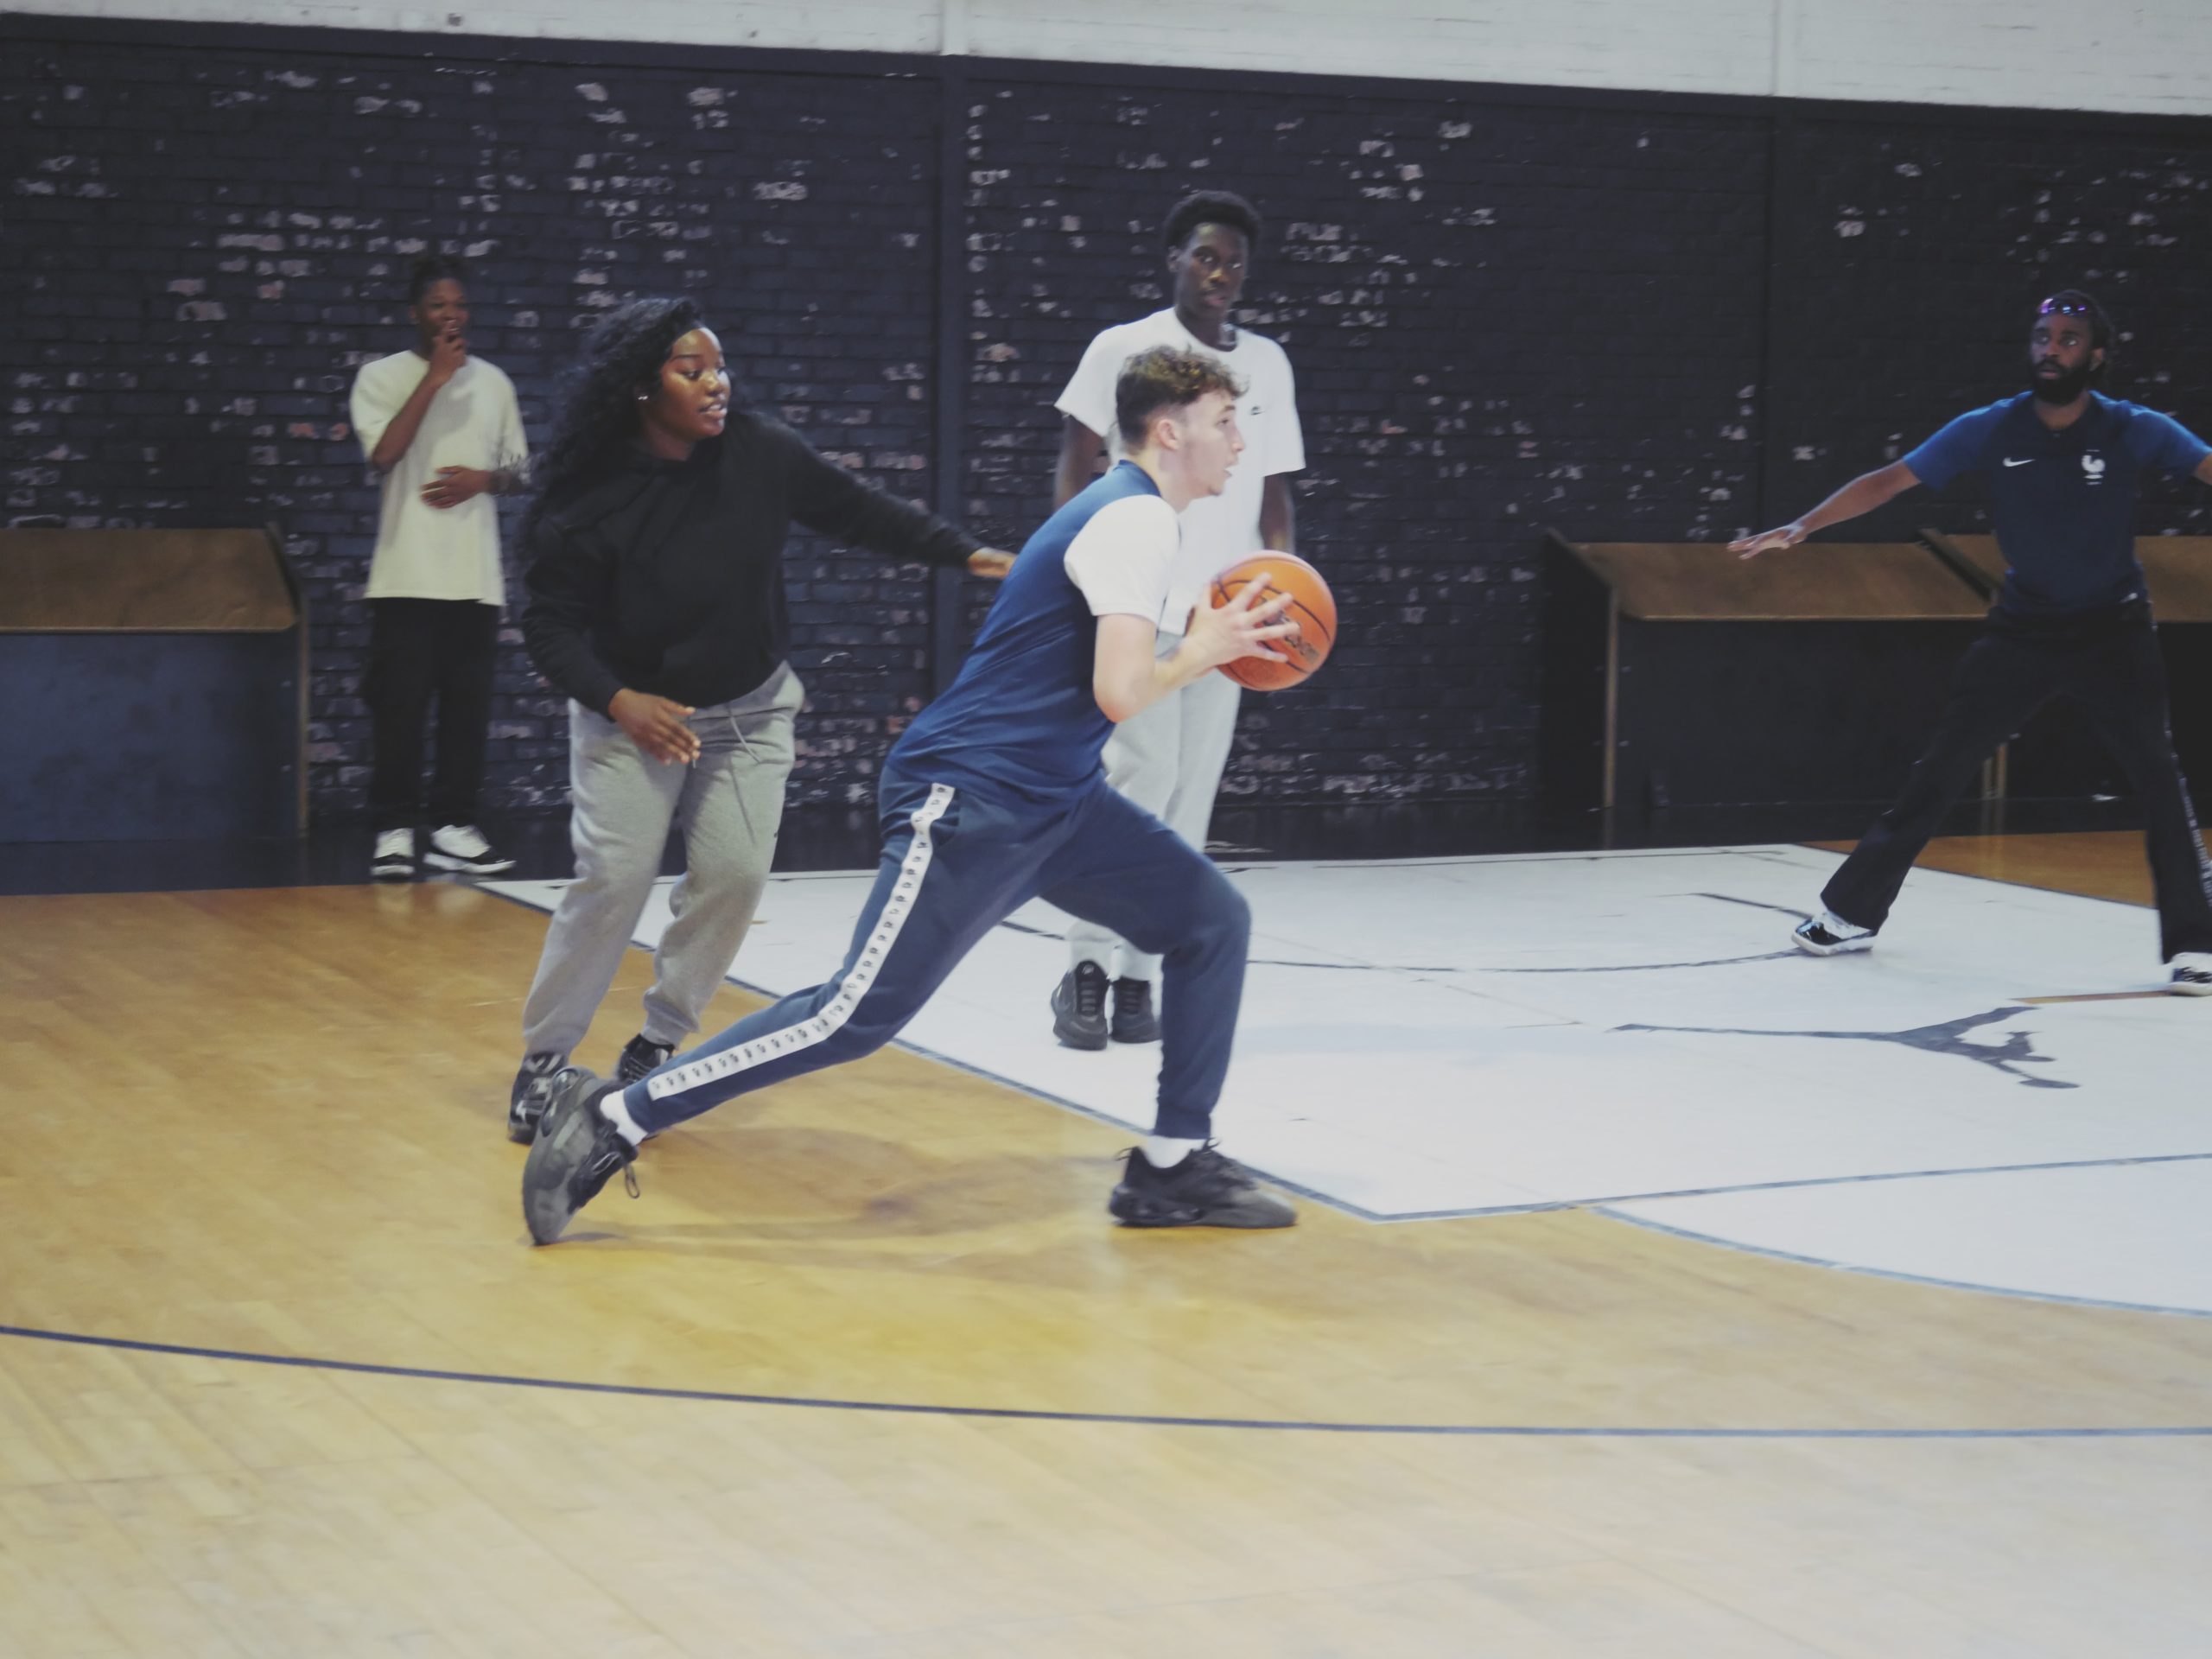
left=360, top=600, right=500, bottom=830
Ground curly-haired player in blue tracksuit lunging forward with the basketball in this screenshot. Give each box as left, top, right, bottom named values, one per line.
left=522, top=347, right=1296, bottom=1243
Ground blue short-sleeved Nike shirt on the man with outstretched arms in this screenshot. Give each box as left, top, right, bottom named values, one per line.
left=1904, top=391, right=2212, bottom=617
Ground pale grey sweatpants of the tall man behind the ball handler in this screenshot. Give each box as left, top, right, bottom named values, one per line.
left=1068, top=632, right=1239, bottom=980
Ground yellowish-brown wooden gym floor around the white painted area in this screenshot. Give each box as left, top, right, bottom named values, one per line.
left=0, top=836, right=2212, bottom=1659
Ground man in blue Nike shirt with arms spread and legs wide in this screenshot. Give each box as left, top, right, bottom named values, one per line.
left=1732, top=288, right=2212, bottom=995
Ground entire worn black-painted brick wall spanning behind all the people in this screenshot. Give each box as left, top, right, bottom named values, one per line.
left=13, top=20, right=2212, bottom=818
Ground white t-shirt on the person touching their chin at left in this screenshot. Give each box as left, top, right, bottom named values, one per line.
left=354, top=352, right=529, bottom=604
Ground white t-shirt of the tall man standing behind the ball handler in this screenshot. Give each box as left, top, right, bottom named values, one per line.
left=1053, top=308, right=1305, bottom=632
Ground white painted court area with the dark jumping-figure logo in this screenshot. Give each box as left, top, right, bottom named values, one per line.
left=486, top=847, right=2212, bottom=1312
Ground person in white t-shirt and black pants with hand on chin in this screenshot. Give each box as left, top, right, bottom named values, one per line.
left=354, top=254, right=529, bottom=880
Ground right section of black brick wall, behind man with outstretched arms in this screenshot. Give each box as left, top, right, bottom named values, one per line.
left=1767, top=119, right=2212, bottom=546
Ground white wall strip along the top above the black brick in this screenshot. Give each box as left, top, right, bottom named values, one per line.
left=24, top=0, right=2212, bottom=115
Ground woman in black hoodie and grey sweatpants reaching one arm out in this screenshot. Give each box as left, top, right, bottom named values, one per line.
left=506, top=299, right=1013, bottom=1141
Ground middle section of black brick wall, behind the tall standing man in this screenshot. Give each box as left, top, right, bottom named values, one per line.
left=967, top=82, right=1765, bottom=801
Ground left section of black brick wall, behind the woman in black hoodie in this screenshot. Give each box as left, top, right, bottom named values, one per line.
left=0, top=44, right=936, bottom=818
